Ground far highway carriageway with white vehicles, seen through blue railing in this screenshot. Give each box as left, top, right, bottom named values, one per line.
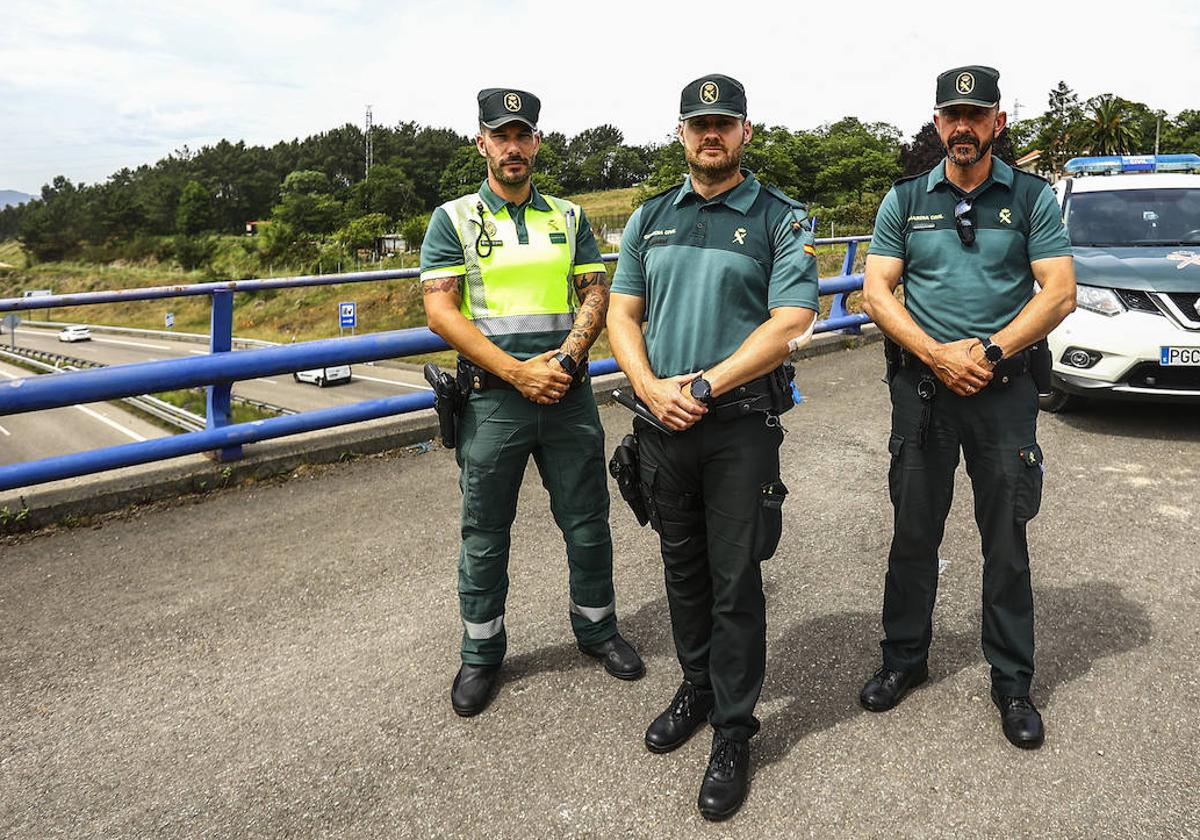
left=2, top=326, right=428, bottom=412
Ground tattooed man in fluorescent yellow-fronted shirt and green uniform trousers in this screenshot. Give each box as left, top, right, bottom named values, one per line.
left=421, top=88, right=643, bottom=716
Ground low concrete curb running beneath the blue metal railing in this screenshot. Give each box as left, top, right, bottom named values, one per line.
left=0, top=324, right=882, bottom=534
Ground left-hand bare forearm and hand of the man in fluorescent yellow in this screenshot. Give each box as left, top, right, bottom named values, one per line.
left=421, top=277, right=571, bottom=406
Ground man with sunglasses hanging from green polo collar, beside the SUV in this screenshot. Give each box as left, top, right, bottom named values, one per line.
left=859, top=66, right=1075, bottom=749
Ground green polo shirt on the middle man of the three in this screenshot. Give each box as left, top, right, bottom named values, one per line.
left=612, top=170, right=817, bottom=377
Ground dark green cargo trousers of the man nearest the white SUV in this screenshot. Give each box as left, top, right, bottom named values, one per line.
left=882, top=367, right=1043, bottom=696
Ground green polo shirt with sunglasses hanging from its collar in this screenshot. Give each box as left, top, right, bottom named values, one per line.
left=871, top=157, right=1070, bottom=343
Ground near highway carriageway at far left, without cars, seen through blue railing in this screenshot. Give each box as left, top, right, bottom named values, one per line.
left=0, top=362, right=169, bottom=464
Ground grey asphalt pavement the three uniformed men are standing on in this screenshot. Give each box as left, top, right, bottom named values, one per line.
left=0, top=347, right=1200, bottom=840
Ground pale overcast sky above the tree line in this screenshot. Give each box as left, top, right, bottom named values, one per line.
left=0, top=0, right=1200, bottom=193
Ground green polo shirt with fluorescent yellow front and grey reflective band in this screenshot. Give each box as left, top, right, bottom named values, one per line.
left=421, top=181, right=605, bottom=359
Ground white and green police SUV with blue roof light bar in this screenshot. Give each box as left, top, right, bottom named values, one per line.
left=1042, top=155, right=1200, bottom=412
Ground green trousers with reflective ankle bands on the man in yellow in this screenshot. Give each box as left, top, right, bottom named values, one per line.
left=455, top=385, right=617, bottom=665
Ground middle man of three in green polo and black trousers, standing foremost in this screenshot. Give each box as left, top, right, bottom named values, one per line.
left=608, top=74, right=817, bottom=820
